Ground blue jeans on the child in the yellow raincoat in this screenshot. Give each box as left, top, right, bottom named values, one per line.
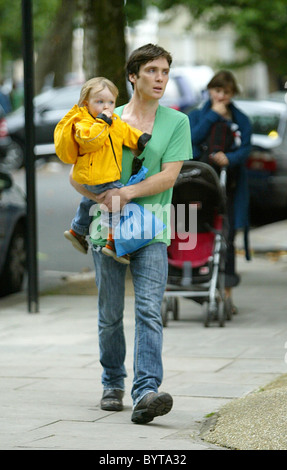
left=71, top=181, right=123, bottom=236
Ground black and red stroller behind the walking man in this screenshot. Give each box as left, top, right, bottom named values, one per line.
left=161, top=161, right=231, bottom=327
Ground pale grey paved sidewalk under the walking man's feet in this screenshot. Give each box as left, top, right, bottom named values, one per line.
left=0, top=224, right=287, bottom=450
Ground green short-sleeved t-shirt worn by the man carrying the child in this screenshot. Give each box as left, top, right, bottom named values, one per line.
left=90, top=106, right=192, bottom=245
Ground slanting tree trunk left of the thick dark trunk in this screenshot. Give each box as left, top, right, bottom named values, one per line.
left=35, top=0, right=77, bottom=94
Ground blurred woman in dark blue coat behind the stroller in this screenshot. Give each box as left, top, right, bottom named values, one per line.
left=189, top=70, right=252, bottom=314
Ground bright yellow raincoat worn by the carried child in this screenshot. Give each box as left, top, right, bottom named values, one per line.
left=54, top=105, right=146, bottom=185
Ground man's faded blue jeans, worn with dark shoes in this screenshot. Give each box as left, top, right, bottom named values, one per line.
left=93, top=243, right=168, bottom=405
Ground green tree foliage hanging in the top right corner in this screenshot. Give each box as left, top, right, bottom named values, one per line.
left=152, top=0, right=287, bottom=87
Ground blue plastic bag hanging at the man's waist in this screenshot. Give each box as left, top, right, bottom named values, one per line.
left=114, top=202, right=166, bottom=256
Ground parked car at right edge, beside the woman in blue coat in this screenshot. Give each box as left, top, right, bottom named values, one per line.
left=236, top=100, right=287, bottom=217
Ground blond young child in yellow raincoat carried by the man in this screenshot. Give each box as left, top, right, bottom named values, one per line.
left=54, top=77, right=151, bottom=264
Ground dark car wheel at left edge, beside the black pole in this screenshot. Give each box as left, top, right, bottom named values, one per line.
left=0, top=225, right=26, bottom=296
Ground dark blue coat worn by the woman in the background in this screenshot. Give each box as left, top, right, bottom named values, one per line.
left=188, top=100, right=252, bottom=256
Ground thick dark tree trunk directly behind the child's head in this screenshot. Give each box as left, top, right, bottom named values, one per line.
left=80, top=0, right=128, bottom=104
